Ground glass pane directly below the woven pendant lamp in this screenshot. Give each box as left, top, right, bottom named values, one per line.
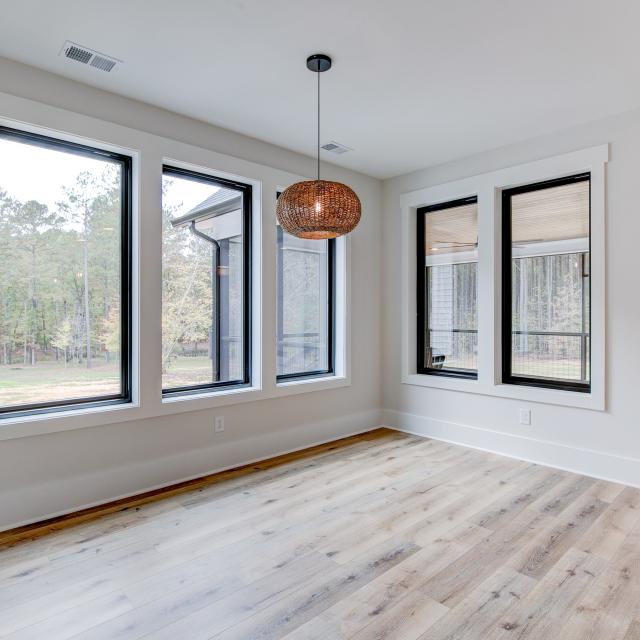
left=278, top=227, right=330, bottom=376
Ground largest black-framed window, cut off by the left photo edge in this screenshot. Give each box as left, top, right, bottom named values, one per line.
left=0, top=127, right=131, bottom=416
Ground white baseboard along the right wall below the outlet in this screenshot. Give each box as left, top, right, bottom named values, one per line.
left=382, top=410, right=640, bottom=487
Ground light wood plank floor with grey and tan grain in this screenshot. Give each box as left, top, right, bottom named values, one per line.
left=0, top=430, right=640, bottom=640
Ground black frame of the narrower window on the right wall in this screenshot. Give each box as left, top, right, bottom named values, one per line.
left=416, top=195, right=478, bottom=380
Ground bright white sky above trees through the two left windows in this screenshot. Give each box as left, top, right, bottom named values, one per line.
left=0, top=138, right=218, bottom=225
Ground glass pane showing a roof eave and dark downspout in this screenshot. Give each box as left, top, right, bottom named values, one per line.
left=162, top=172, right=244, bottom=390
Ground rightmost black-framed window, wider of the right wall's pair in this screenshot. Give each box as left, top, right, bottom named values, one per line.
left=502, top=174, right=591, bottom=391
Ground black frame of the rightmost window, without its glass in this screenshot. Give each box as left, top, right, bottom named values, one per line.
left=500, top=171, right=592, bottom=393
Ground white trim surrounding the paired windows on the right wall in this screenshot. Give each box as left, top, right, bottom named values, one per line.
left=400, top=144, right=609, bottom=411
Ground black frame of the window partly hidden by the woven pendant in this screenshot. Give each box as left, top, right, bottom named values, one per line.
left=276, top=192, right=336, bottom=383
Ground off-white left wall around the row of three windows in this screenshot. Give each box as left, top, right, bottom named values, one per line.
left=0, top=59, right=381, bottom=530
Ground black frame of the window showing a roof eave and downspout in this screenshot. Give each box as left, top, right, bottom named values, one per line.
left=162, top=164, right=253, bottom=398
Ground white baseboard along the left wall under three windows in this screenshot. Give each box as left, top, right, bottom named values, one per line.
left=0, top=410, right=380, bottom=532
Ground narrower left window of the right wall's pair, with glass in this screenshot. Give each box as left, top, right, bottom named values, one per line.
left=417, top=197, right=478, bottom=378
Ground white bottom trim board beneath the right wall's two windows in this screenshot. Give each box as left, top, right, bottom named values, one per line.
left=402, top=373, right=605, bottom=411
